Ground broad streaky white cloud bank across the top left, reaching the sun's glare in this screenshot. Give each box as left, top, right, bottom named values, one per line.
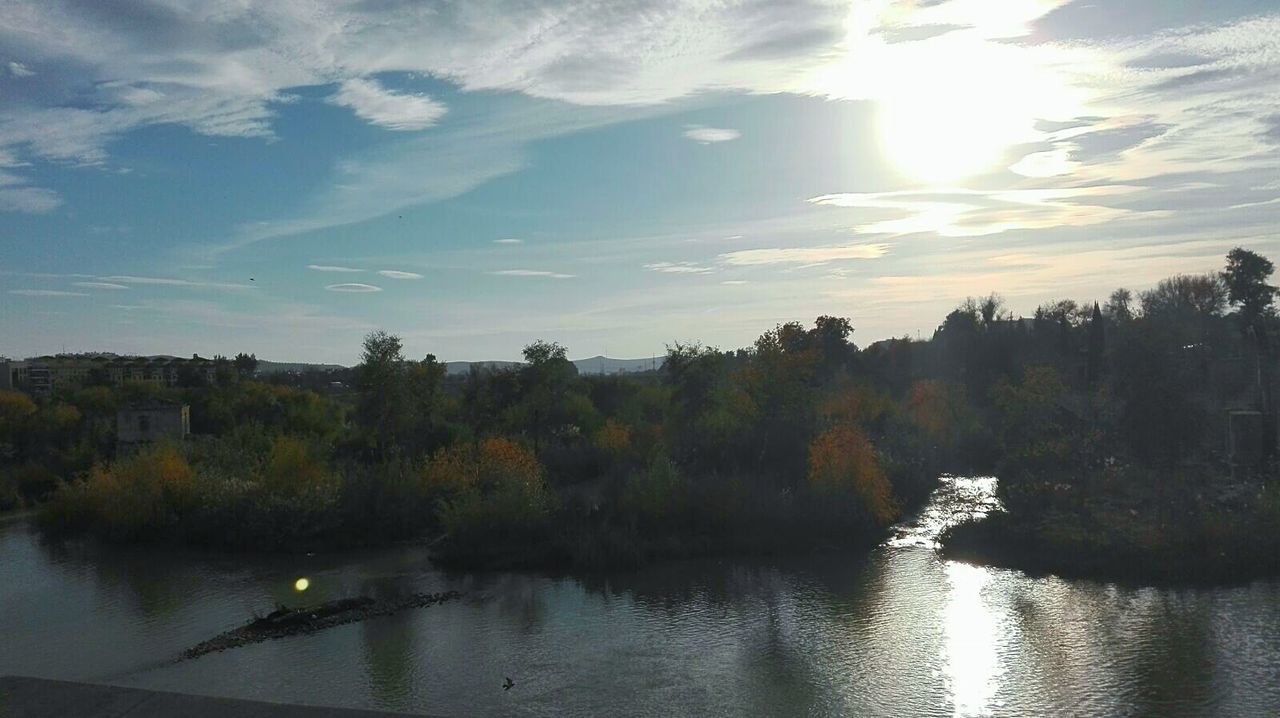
left=0, top=0, right=847, bottom=163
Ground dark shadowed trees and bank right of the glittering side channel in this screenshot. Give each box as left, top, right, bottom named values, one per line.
left=943, top=250, right=1280, bottom=582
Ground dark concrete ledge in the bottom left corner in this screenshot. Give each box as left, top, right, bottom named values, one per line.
left=0, top=677, right=430, bottom=718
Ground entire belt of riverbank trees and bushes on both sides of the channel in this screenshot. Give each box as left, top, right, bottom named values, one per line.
left=15, top=250, right=1280, bottom=580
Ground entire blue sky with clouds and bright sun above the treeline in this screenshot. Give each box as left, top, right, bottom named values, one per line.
left=0, top=0, right=1280, bottom=363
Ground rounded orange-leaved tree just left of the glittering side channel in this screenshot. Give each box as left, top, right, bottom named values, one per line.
left=809, top=424, right=899, bottom=525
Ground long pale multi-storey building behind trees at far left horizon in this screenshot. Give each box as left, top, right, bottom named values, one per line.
left=0, top=355, right=218, bottom=394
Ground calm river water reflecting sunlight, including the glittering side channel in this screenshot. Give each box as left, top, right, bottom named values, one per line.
left=0, top=479, right=1280, bottom=715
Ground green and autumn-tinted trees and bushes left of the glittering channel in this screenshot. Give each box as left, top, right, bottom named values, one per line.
left=22, top=317, right=968, bottom=567
